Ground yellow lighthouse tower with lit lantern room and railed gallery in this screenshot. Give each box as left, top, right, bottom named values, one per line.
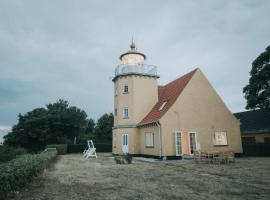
left=113, top=41, right=159, bottom=154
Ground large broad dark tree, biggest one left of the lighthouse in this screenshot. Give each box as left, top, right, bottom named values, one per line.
left=4, top=99, right=88, bottom=151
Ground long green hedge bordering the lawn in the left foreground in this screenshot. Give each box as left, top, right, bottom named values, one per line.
left=0, top=149, right=57, bottom=200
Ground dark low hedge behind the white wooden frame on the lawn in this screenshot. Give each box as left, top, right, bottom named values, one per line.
left=67, top=143, right=112, bottom=153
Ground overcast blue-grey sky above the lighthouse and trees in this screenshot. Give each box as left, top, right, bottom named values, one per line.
left=0, top=0, right=270, bottom=126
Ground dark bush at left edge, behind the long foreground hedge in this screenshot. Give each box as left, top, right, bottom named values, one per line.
left=0, top=145, right=26, bottom=163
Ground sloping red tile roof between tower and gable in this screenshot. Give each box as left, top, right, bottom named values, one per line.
left=138, top=69, right=197, bottom=125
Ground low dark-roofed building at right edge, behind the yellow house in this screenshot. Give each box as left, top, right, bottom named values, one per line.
left=234, top=110, right=270, bottom=143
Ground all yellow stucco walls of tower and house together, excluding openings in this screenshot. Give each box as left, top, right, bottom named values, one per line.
left=113, top=70, right=242, bottom=156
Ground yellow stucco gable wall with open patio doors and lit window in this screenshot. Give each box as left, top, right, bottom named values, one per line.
left=160, top=70, right=242, bottom=156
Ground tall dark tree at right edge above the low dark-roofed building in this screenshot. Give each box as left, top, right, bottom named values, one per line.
left=243, top=46, right=270, bottom=110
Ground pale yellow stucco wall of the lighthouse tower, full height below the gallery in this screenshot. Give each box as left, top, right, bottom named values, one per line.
left=113, top=75, right=158, bottom=154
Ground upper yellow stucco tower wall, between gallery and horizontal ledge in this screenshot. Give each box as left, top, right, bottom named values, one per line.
left=114, top=75, right=158, bottom=126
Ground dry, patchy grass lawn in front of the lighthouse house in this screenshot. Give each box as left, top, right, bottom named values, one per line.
left=9, top=154, right=270, bottom=200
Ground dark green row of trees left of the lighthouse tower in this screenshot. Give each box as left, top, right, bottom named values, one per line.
left=4, top=99, right=113, bottom=151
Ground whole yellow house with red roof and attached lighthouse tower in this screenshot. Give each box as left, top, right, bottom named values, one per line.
left=112, top=42, right=242, bottom=159
